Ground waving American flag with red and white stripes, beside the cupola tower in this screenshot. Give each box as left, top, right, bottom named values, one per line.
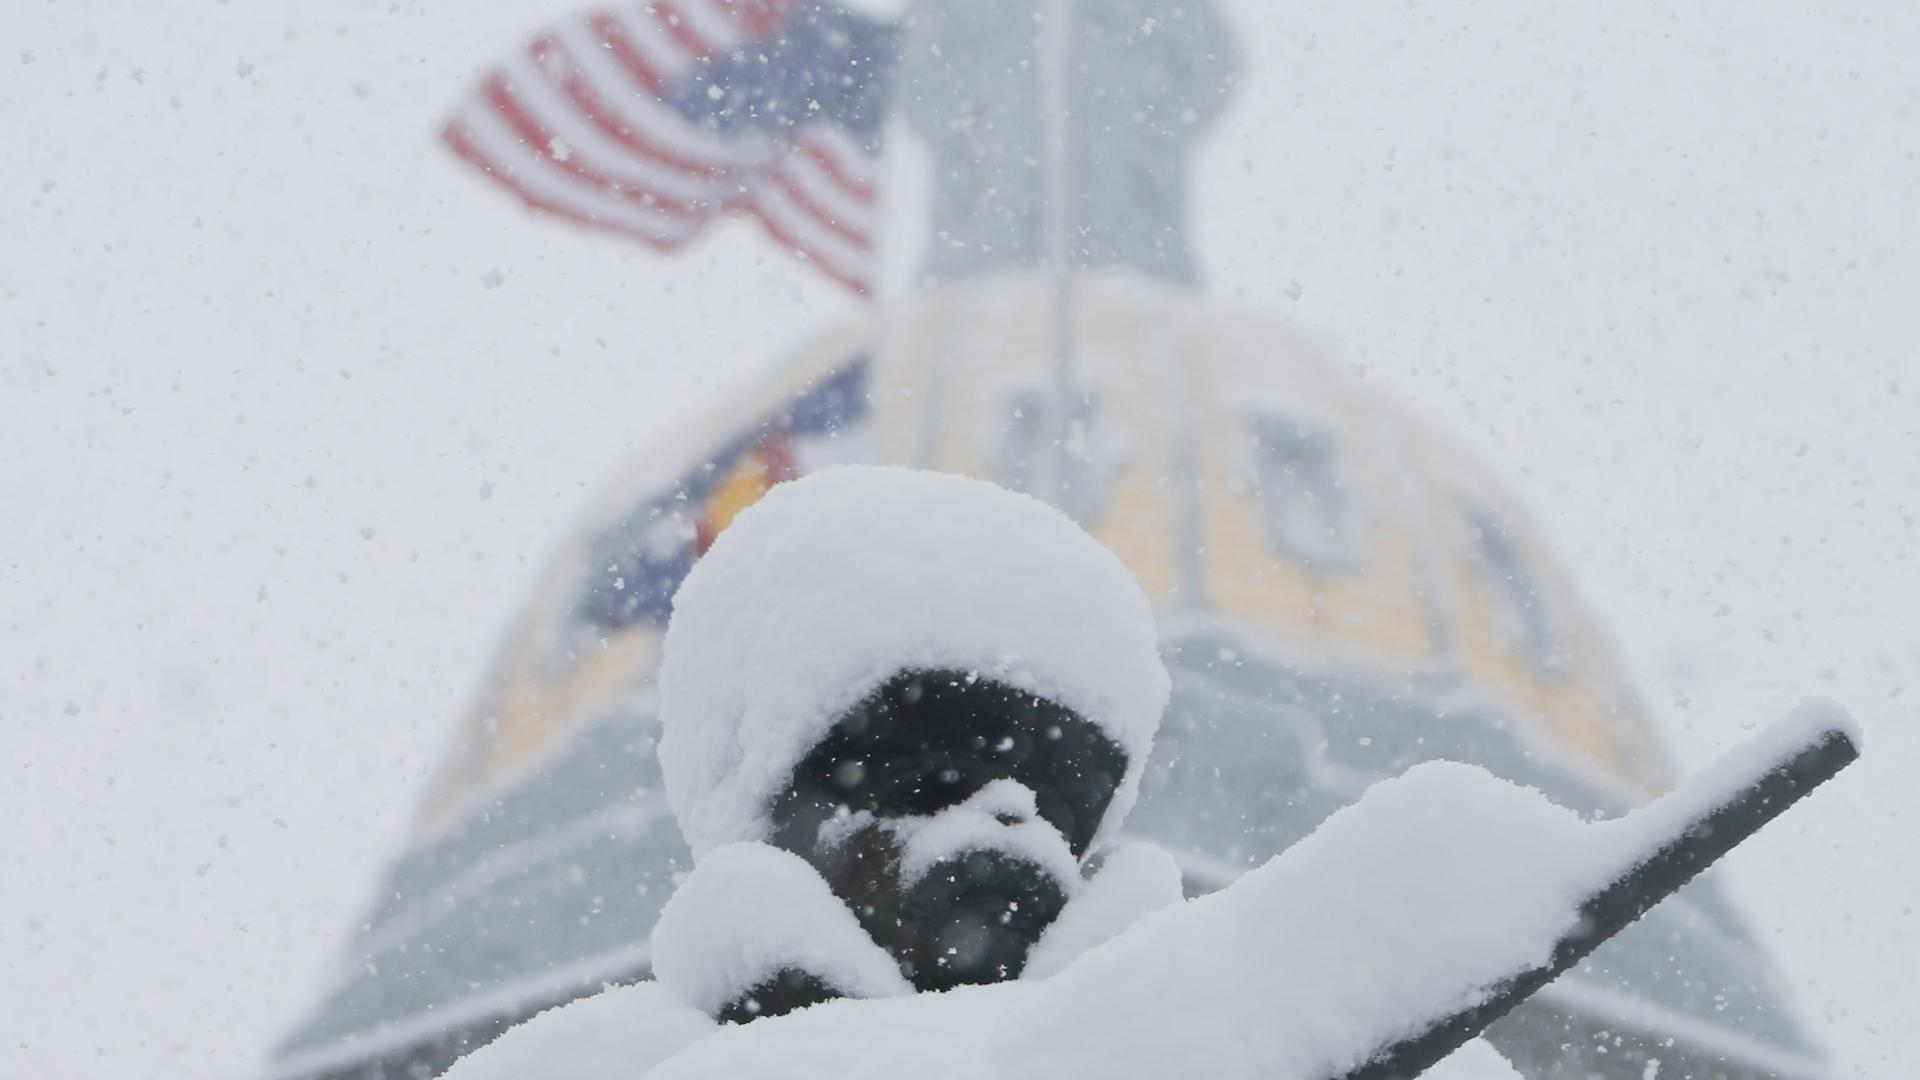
left=442, top=0, right=895, bottom=294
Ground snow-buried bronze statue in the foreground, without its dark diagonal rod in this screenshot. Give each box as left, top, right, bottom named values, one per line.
left=449, top=467, right=1543, bottom=1080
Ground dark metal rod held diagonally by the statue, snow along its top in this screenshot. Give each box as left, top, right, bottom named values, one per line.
left=1334, top=714, right=1860, bottom=1080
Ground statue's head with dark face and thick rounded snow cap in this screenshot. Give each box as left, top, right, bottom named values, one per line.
left=660, top=467, right=1169, bottom=1011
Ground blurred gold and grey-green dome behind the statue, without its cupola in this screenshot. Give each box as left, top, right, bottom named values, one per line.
left=276, top=269, right=1826, bottom=1080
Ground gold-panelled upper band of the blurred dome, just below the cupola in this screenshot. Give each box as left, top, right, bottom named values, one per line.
left=426, top=273, right=1663, bottom=822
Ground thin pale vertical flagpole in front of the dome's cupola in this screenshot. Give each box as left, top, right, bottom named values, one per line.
left=1039, top=0, right=1075, bottom=509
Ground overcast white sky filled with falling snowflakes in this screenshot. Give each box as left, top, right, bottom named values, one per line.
left=0, top=0, right=1920, bottom=1080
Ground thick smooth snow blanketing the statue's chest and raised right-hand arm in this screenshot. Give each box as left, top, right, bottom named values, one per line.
left=637, top=765, right=1592, bottom=1080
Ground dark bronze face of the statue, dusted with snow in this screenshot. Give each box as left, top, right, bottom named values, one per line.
left=772, top=671, right=1127, bottom=990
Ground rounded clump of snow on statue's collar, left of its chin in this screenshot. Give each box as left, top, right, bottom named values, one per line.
left=653, top=844, right=914, bottom=1015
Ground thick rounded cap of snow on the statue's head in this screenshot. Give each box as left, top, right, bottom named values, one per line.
left=660, top=467, right=1169, bottom=857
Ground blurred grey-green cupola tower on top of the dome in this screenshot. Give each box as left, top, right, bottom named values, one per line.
left=897, top=0, right=1236, bottom=282
